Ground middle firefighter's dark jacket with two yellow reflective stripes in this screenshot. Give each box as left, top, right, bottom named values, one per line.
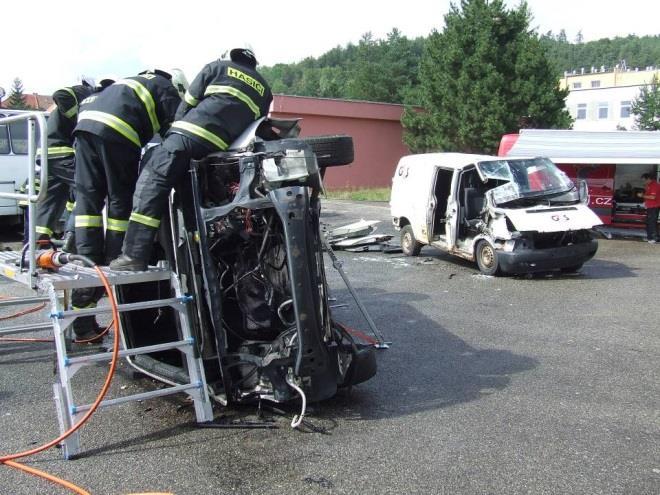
left=75, top=73, right=181, bottom=148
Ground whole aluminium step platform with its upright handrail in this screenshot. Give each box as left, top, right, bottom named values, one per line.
left=0, top=112, right=213, bottom=459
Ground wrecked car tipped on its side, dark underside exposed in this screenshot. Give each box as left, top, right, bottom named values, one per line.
left=119, top=119, right=376, bottom=403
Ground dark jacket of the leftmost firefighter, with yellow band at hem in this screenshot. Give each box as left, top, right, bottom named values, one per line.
left=42, top=84, right=93, bottom=159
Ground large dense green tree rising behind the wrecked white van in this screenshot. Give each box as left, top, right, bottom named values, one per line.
left=402, top=0, right=571, bottom=153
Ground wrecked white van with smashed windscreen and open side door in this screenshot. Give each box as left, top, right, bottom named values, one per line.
left=390, top=153, right=602, bottom=275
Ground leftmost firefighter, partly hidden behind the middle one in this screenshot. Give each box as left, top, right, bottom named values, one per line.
left=35, top=76, right=114, bottom=250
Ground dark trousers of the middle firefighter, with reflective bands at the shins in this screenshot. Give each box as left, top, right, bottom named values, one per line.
left=74, top=132, right=140, bottom=264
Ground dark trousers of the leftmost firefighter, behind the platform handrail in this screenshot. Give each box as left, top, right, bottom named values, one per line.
left=35, top=155, right=75, bottom=237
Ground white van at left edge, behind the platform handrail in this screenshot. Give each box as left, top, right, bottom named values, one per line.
left=0, top=108, right=45, bottom=224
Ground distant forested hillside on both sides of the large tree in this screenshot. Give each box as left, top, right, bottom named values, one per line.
left=260, top=29, right=660, bottom=104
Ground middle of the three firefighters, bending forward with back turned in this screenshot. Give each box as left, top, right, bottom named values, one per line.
left=72, top=69, right=181, bottom=339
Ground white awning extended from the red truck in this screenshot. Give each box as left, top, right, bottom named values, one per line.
left=506, top=129, right=660, bottom=165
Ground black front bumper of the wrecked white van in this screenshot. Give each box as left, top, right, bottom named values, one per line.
left=497, top=239, right=598, bottom=273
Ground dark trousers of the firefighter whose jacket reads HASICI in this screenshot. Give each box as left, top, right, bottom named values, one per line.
left=122, top=133, right=212, bottom=261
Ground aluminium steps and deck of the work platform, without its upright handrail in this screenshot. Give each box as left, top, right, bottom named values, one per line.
left=0, top=251, right=213, bottom=459
